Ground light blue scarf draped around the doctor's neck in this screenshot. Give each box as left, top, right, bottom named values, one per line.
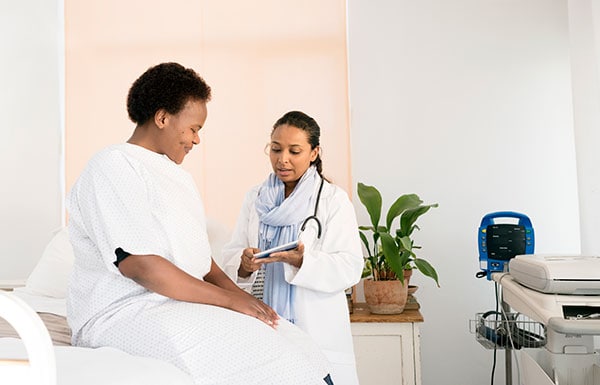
left=256, top=166, right=319, bottom=323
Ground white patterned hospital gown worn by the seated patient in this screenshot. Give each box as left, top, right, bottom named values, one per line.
left=67, top=144, right=328, bottom=385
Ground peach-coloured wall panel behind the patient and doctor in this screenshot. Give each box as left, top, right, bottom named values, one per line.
left=65, top=0, right=352, bottom=227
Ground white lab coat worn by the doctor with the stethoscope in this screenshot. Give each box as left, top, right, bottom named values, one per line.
left=223, top=182, right=364, bottom=385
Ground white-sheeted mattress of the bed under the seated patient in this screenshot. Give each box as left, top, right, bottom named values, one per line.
left=0, top=290, right=193, bottom=385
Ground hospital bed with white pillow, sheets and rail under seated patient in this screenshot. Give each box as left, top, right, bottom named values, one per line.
left=0, top=221, right=228, bottom=385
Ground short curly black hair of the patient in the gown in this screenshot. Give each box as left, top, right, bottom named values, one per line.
left=127, top=63, right=210, bottom=125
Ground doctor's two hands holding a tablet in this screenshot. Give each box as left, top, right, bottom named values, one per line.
left=238, top=241, right=304, bottom=277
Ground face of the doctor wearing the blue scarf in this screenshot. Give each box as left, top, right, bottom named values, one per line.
left=269, top=124, right=319, bottom=191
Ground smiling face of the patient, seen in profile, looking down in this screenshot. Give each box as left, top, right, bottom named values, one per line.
left=158, top=100, right=208, bottom=164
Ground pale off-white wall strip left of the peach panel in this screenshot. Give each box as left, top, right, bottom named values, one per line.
left=0, top=0, right=64, bottom=285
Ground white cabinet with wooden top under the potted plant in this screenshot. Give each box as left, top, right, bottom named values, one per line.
left=350, top=303, right=423, bottom=385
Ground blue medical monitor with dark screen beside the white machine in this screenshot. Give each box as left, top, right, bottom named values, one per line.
left=476, top=211, right=535, bottom=281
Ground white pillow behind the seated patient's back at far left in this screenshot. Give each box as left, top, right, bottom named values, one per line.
left=24, top=227, right=75, bottom=298
